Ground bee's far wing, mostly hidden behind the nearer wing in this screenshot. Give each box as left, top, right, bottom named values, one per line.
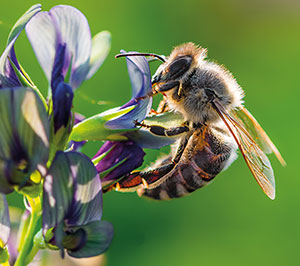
left=232, top=107, right=286, bottom=166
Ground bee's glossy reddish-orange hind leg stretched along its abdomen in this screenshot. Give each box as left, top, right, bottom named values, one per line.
left=113, top=134, right=191, bottom=192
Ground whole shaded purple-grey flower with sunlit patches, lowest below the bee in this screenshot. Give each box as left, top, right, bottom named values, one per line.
left=43, top=152, right=113, bottom=258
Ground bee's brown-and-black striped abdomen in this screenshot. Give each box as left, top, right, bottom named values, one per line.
left=139, top=127, right=236, bottom=200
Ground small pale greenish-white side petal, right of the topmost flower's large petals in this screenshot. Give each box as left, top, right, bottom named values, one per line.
left=87, top=31, right=111, bottom=79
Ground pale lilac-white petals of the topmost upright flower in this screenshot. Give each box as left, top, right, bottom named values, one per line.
left=26, top=5, right=111, bottom=89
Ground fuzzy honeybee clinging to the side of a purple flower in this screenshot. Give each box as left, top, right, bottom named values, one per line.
left=113, top=43, right=285, bottom=200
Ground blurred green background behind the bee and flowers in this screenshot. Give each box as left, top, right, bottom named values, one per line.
left=0, top=0, right=300, bottom=266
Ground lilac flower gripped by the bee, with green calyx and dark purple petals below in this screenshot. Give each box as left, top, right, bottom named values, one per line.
left=70, top=51, right=177, bottom=188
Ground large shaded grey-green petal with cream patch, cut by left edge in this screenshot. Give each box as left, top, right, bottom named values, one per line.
left=0, top=88, right=49, bottom=192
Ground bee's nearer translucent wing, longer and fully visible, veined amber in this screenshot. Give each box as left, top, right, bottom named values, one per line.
left=213, top=100, right=275, bottom=199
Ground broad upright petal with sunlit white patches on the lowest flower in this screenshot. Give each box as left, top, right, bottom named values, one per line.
left=43, top=152, right=102, bottom=234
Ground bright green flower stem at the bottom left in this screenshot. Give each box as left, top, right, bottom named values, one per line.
left=15, top=197, right=41, bottom=266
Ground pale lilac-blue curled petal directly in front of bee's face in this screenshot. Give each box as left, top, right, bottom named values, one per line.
left=105, top=52, right=152, bottom=129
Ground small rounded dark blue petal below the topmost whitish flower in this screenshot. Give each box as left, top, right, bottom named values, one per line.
left=53, top=82, right=74, bottom=132
